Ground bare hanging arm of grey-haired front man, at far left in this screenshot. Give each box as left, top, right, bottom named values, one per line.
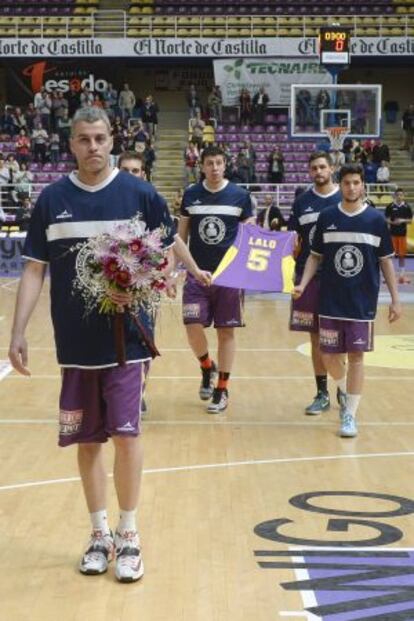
left=9, top=261, right=46, bottom=375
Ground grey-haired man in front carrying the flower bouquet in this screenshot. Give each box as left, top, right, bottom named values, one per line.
left=9, top=107, right=174, bottom=582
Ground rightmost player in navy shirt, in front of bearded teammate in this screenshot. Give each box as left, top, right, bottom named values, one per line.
left=294, top=164, right=401, bottom=438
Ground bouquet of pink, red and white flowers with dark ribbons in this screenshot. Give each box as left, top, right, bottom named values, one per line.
left=72, top=216, right=168, bottom=365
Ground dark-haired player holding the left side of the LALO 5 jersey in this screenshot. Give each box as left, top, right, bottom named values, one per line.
left=178, top=146, right=252, bottom=414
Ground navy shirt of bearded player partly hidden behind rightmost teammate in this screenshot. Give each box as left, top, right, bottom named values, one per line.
left=288, top=187, right=341, bottom=274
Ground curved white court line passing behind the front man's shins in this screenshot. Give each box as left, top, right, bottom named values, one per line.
left=0, top=451, right=414, bottom=492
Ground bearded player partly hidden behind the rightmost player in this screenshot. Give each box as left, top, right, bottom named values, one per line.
left=288, top=151, right=341, bottom=415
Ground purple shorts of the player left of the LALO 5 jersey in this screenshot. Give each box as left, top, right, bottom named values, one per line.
left=183, top=274, right=244, bottom=328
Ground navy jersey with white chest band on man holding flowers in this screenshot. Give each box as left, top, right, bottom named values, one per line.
left=23, top=169, right=174, bottom=368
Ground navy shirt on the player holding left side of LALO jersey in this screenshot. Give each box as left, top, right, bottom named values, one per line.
left=181, top=182, right=253, bottom=272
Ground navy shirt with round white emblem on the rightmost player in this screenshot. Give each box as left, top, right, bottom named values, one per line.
left=312, top=204, right=393, bottom=321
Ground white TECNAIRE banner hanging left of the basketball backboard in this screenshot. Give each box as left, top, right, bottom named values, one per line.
left=214, top=58, right=332, bottom=106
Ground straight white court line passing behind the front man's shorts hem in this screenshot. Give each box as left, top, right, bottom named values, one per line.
left=0, top=415, right=414, bottom=427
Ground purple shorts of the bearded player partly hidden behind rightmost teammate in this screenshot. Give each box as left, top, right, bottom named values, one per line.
left=289, top=274, right=320, bottom=332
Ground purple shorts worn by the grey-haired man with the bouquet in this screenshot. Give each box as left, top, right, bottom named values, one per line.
left=59, top=362, right=147, bottom=446
